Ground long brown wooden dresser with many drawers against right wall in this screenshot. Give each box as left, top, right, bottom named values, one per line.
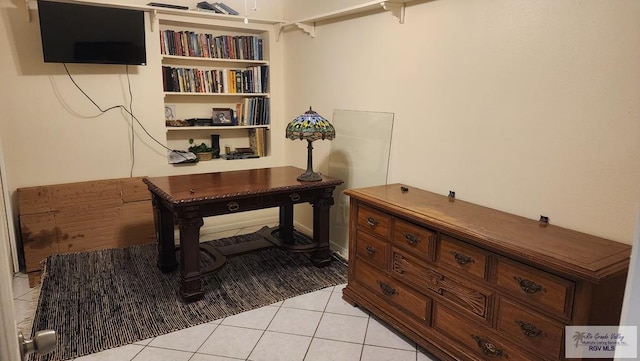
left=343, top=184, right=631, bottom=361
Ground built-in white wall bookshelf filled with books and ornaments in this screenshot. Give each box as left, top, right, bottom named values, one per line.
left=158, top=16, right=273, bottom=163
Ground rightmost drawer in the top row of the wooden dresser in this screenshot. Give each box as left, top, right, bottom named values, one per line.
left=497, top=258, right=574, bottom=319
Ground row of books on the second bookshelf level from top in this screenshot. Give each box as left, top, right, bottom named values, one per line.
left=162, top=65, right=269, bottom=93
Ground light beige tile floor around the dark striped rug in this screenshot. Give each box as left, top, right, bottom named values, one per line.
left=13, top=227, right=436, bottom=361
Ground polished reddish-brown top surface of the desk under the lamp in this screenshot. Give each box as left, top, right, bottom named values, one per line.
left=143, top=167, right=343, bottom=204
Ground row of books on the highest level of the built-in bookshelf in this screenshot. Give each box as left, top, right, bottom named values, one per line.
left=160, top=30, right=263, bottom=60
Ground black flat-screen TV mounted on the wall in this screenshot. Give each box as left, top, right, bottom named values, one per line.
left=38, top=0, right=147, bottom=65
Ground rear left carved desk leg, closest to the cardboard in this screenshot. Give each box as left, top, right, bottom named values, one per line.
left=151, top=194, right=178, bottom=272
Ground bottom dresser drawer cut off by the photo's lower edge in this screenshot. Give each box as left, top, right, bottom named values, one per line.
left=433, top=302, right=537, bottom=361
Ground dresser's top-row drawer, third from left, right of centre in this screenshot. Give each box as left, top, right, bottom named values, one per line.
left=437, top=236, right=490, bottom=279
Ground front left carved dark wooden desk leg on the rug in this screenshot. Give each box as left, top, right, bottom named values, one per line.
left=178, top=207, right=204, bottom=302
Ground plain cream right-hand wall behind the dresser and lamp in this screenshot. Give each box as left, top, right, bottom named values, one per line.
left=283, top=0, right=640, bottom=243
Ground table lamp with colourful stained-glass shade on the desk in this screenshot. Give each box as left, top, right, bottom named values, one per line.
left=287, top=107, right=336, bottom=182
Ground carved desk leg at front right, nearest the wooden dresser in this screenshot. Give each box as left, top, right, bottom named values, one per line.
left=311, top=187, right=335, bottom=267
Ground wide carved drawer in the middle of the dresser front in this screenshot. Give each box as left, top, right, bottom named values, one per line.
left=391, top=247, right=493, bottom=323
